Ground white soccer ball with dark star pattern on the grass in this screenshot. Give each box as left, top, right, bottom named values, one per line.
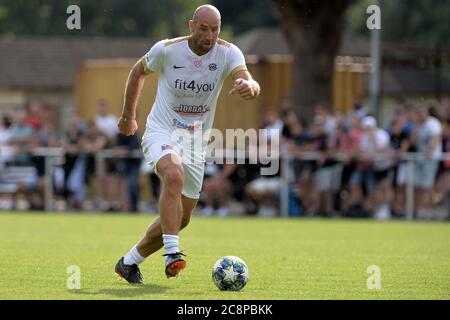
left=212, top=256, right=248, bottom=291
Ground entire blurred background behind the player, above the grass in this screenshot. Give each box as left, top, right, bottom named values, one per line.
left=0, top=0, right=450, bottom=219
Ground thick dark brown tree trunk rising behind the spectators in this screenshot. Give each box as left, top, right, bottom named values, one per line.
left=273, top=0, right=350, bottom=121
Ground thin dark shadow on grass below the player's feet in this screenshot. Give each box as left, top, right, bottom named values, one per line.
left=69, top=284, right=168, bottom=298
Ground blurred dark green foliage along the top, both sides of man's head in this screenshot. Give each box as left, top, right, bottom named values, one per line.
left=0, top=0, right=279, bottom=39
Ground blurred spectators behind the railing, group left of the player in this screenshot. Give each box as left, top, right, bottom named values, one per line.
left=0, top=100, right=141, bottom=212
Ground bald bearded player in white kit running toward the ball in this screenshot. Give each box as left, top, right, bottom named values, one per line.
left=115, top=5, right=260, bottom=283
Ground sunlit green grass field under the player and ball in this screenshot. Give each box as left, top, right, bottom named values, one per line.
left=0, top=212, right=450, bottom=300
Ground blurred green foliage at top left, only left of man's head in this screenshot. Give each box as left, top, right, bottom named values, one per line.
left=0, top=0, right=205, bottom=37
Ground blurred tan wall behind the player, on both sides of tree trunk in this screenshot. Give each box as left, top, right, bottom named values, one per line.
left=75, top=60, right=362, bottom=134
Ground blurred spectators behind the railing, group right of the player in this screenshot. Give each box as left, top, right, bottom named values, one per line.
left=203, top=100, right=450, bottom=219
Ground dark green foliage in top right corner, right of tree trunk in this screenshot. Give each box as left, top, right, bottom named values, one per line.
left=347, top=0, right=450, bottom=46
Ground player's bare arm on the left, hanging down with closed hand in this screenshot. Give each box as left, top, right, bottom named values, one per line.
left=118, top=59, right=148, bottom=136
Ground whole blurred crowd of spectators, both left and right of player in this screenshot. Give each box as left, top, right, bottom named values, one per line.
left=0, top=100, right=450, bottom=219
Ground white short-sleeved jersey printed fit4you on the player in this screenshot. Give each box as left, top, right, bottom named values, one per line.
left=141, top=37, right=246, bottom=133
